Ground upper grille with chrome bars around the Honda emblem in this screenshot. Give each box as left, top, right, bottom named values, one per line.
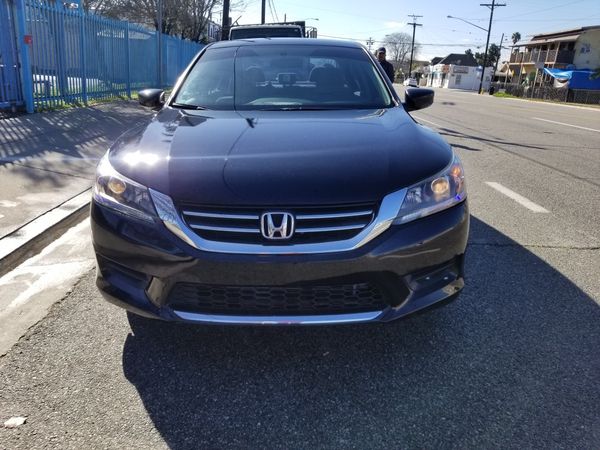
left=180, top=204, right=375, bottom=245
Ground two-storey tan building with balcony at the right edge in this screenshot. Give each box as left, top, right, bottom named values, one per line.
left=509, top=25, right=600, bottom=83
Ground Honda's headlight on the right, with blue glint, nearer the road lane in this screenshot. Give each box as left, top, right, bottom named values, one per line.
left=394, top=156, right=467, bottom=225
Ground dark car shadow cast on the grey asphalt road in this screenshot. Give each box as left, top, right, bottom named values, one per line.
left=123, top=217, right=600, bottom=448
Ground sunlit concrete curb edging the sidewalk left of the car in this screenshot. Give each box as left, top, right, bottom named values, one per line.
left=0, top=188, right=92, bottom=277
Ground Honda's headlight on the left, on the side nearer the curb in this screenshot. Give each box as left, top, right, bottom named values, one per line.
left=94, top=152, right=157, bottom=222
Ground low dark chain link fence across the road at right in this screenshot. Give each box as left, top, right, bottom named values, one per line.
left=492, top=82, right=600, bottom=105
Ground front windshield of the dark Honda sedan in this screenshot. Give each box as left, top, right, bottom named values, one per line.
left=172, top=44, right=394, bottom=110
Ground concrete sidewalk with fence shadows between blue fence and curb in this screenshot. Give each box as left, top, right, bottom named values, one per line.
left=0, top=101, right=152, bottom=274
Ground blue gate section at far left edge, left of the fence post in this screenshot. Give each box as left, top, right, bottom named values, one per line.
left=0, top=0, right=23, bottom=108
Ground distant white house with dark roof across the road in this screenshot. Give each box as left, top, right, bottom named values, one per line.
left=427, top=53, right=494, bottom=91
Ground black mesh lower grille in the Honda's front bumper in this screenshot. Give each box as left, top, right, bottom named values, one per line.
left=168, top=283, right=387, bottom=316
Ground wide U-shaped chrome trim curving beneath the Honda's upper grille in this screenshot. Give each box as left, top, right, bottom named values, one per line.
left=149, top=189, right=406, bottom=255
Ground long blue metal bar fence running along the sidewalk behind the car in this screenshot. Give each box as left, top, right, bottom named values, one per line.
left=0, top=0, right=202, bottom=110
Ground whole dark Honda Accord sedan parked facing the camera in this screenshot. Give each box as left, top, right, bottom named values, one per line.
left=91, top=38, right=469, bottom=325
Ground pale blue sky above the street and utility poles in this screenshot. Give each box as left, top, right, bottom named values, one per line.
left=231, top=0, right=600, bottom=59
